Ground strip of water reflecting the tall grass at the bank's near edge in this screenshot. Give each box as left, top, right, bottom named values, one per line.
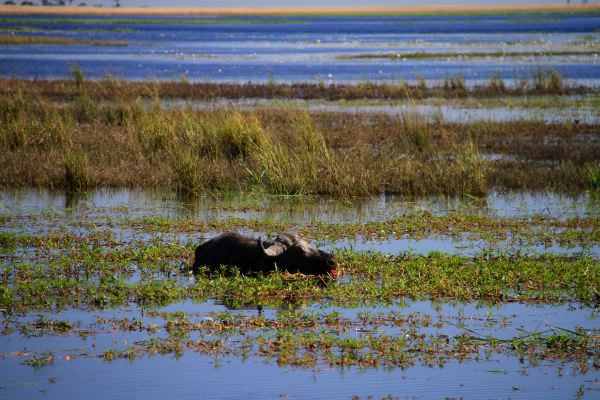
left=0, top=188, right=600, bottom=224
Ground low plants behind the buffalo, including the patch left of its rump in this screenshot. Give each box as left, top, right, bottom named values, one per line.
left=5, top=212, right=600, bottom=253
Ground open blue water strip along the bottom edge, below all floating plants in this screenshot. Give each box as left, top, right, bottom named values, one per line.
left=0, top=354, right=598, bottom=400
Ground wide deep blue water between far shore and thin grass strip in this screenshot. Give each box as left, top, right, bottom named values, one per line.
left=0, top=15, right=600, bottom=86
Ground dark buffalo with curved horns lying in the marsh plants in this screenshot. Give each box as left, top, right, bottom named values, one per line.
left=192, top=232, right=338, bottom=277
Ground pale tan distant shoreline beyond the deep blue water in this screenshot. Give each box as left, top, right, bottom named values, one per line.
left=0, top=4, right=600, bottom=16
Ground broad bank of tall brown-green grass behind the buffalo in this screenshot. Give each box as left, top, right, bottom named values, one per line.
left=0, top=83, right=600, bottom=196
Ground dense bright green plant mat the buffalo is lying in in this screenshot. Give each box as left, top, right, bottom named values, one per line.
left=1, top=250, right=600, bottom=309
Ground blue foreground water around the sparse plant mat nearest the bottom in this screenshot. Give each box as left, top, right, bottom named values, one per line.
left=0, top=302, right=600, bottom=399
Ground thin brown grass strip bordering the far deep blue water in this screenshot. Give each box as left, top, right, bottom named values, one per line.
left=0, top=68, right=598, bottom=101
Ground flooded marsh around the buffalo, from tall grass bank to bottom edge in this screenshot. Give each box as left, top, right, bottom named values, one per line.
left=0, top=189, right=600, bottom=398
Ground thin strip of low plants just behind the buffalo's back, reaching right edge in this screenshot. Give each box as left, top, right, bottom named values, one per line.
left=120, top=213, right=600, bottom=245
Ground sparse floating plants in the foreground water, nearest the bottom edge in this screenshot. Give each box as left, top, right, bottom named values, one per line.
left=5, top=309, right=600, bottom=368
